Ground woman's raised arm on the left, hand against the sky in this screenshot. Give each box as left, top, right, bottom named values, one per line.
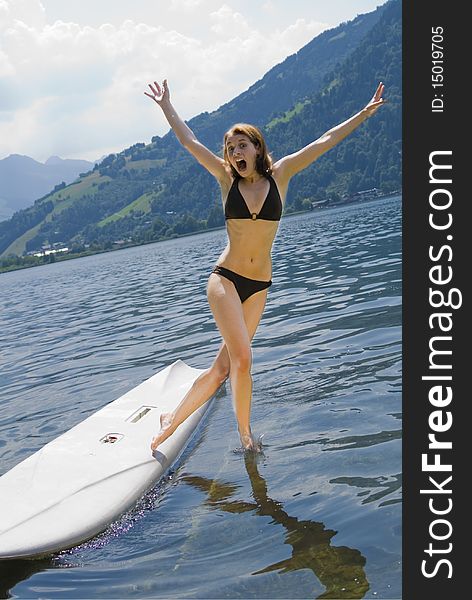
left=144, top=79, right=228, bottom=182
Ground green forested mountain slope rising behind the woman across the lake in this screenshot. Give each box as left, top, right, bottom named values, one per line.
left=0, top=0, right=401, bottom=256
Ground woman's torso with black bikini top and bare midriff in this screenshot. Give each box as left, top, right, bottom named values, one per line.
left=217, top=171, right=285, bottom=281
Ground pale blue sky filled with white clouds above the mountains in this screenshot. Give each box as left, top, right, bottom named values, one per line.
left=0, top=0, right=384, bottom=161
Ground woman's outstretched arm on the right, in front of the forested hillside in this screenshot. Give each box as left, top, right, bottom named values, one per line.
left=274, top=83, right=385, bottom=184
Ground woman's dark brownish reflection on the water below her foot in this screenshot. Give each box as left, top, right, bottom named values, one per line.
left=183, top=455, right=369, bottom=600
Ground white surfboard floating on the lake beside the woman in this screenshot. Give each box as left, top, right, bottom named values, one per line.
left=0, top=361, right=210, bottom=559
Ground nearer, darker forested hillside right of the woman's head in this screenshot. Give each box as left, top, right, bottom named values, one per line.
left=267, top=2, right=402, bottom=203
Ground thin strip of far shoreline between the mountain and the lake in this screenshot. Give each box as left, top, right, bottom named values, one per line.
left=0, top=190, right=402, bottom=275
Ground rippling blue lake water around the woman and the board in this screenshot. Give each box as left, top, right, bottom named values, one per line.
left=0, top=197, right=401, bottom=599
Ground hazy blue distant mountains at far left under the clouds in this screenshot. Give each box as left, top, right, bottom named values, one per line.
left=0, top=154, right=95, bottom=221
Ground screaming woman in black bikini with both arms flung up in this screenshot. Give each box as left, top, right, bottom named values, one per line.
left=144, top=80, right=384, bottom=452
